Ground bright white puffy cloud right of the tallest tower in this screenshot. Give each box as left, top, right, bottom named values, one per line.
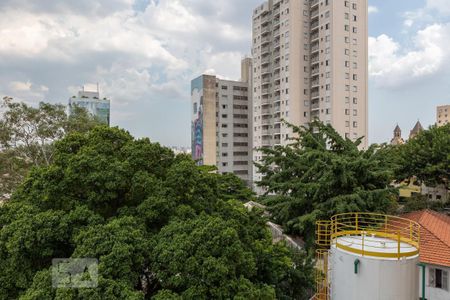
left=369, top=24, right=450, bottom=87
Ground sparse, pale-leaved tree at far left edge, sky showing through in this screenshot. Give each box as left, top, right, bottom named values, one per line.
left=0, top=97, right=99, bottom=198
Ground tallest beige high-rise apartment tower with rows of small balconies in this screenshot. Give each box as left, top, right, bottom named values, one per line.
left=252, top=0, right=368, bottom=181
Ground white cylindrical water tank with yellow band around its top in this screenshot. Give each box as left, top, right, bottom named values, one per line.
left=328, top=234, right=419, bottom=300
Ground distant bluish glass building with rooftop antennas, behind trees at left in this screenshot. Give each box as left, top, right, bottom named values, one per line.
left=69, top=89, right=110, bottom=126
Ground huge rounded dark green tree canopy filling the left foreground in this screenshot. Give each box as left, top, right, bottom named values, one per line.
left=0, top=127, right=312, bottom=299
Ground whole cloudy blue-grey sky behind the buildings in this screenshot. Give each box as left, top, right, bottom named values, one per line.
left=0, top=0, right=450, bottom=146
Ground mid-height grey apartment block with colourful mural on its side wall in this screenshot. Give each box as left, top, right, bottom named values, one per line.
left=191, top=58, right=253, bottom=186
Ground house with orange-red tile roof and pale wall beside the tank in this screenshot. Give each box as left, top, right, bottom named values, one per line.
left=402, top=210, right=450, bottom=300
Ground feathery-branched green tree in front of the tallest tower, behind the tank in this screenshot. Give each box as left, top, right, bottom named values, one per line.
left=257, top=122, right=395, bottom=245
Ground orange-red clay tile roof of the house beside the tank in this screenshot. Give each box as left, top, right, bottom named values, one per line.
left=402, top=209, right=450, bottom=267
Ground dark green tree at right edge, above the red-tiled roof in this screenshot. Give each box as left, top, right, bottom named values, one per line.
left=396, top=124, right=450, bottom=189
